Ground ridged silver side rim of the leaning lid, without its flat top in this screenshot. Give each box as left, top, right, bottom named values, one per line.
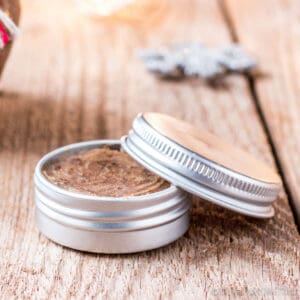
left=121, top=115, right=280, bottom=218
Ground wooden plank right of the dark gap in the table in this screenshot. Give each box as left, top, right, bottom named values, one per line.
left=226, top=0, right=300, bottom=227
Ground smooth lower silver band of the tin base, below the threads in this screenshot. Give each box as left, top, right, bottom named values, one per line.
left=36, top=210, right=189, bottom=254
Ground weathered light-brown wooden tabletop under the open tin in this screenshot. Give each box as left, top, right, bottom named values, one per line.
left=0, top=0, right=300, bottom=299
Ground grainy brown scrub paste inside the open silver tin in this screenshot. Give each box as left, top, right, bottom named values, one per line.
left=43, top=147, right=170, bottom=197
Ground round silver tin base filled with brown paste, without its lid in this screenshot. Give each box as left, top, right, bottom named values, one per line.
left=34, top=140, right=191, bottom=253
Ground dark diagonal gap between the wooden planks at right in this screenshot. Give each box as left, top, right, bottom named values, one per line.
left=218, top=0, right=300, bottom=233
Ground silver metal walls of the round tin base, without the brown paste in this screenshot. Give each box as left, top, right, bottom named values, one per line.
left=34, top=140, right=191, bottom=253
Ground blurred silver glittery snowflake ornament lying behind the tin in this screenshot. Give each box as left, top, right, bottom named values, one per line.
left=139, top=43, right=256, bottom=80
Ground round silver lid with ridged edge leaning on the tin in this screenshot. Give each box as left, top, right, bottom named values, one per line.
left=122, top=113, right=281, bottom=218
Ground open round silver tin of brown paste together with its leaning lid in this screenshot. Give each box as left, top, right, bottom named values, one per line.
left=34, top=113, right=281, bottom=253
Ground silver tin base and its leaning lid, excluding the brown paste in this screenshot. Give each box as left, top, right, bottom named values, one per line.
left=35, top=113, right=281, bottom=253
